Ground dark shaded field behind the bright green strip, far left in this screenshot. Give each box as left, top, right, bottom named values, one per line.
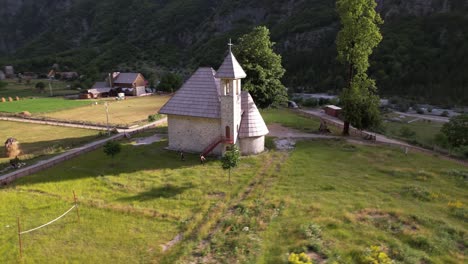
left=0, top=79, right=79, bottom=98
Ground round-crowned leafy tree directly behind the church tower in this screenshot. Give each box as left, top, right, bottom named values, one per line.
left=234, top=26, right=287, bottom=108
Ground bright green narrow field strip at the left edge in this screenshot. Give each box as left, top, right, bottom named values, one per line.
left=0, top=98, right=93, bottom=115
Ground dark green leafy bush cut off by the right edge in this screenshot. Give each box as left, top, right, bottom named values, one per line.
left=441, top=114, right=468, bottom=147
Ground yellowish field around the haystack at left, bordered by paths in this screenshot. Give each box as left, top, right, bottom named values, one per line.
left=0, top=121, right=98, bottom=168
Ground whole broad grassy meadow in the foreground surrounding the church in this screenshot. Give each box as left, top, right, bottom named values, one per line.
left=0, top=136, right=468, bottom=263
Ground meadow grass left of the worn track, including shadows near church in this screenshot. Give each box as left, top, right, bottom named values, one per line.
left=0, top=138, right=268, bottom=263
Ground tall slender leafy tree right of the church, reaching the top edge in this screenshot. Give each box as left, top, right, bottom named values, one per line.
left=336, top=0, right=383, bottom=135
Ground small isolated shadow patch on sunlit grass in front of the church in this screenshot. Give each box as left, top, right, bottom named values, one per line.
left=117, top=183, right=193, bottom=202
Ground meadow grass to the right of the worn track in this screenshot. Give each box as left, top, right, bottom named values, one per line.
left=259, top=141, right=468, bottom=263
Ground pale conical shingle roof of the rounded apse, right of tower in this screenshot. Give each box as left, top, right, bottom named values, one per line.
left=239, top=91, right=269, bottom=138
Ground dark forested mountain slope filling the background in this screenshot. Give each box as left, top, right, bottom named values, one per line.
left=0, top=0, right=468, bottom=104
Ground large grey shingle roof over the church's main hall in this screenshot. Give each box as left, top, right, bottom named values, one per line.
left=159, top=68, right=221, bottom=118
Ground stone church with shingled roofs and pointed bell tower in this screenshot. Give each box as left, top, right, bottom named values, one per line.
left=159, top=50, right=268, bottom=156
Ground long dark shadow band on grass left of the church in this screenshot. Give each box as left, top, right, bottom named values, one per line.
left=7, top=141, right=216, bottom=188
